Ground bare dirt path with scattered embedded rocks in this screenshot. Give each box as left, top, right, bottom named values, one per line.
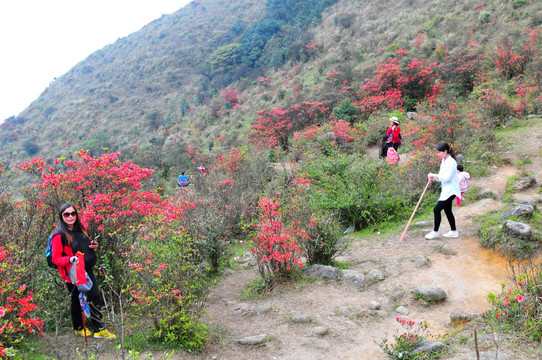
left=182, top=163, right=536, bottom=360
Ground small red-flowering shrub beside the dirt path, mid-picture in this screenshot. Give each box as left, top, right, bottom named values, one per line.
left=252, top=198, right=307, bottom=284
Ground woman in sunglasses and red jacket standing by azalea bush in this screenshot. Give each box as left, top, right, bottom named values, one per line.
left=51, top=203, right=117, bottom=339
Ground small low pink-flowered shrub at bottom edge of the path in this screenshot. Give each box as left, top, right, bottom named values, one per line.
left=378, top=317, right=429, bottom=360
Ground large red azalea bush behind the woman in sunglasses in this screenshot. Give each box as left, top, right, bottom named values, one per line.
left=9, top=151, right=212, bottom=350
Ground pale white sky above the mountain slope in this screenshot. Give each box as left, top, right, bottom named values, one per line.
left=0, top=0, right=190, bottom=123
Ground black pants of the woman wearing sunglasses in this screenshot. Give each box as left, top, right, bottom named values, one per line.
left=66, top=270, right=104, bottom=332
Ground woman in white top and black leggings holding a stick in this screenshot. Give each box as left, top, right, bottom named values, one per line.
left=425, top=141, right=461, bottom=239
